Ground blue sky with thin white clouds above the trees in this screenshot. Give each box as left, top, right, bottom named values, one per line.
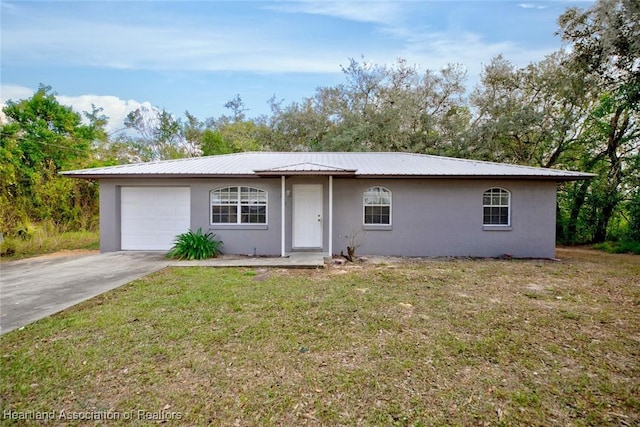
left=0, top=0, right=593, bottom=131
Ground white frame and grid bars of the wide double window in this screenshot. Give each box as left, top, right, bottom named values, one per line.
left=209, top=185, right=269, bottom=228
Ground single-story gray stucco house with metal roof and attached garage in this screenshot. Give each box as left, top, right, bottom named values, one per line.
left=63, top=152, right=592, bottom=258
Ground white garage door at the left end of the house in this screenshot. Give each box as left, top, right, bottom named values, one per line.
left=120, top=187, right=191, bottom=250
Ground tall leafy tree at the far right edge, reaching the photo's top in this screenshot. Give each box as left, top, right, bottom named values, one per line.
left=559, top=0, right=640, bottom=242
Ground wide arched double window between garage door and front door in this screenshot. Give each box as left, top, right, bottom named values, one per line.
left=210, top=187, right=267, bottom=224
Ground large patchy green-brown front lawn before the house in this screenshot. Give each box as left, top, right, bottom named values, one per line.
left=0, top=249, right=640, bottom=426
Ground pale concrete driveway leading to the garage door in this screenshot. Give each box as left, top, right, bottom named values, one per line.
left=0, top=252, right=169, bottom=334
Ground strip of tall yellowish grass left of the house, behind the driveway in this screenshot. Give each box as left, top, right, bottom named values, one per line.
left=0, top=230, right=100, bottom=262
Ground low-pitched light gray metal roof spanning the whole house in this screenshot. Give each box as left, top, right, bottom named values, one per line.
left=62, top=152, right=594, bottom=181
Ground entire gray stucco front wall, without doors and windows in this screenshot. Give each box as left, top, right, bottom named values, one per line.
left=100, top=177, right=556, bottom=258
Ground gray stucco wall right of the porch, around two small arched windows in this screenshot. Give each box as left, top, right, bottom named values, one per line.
left=334, top=179, right=556, bottom=258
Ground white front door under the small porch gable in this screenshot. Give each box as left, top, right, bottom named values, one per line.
left=292, top=184, right=324, bottom=249
